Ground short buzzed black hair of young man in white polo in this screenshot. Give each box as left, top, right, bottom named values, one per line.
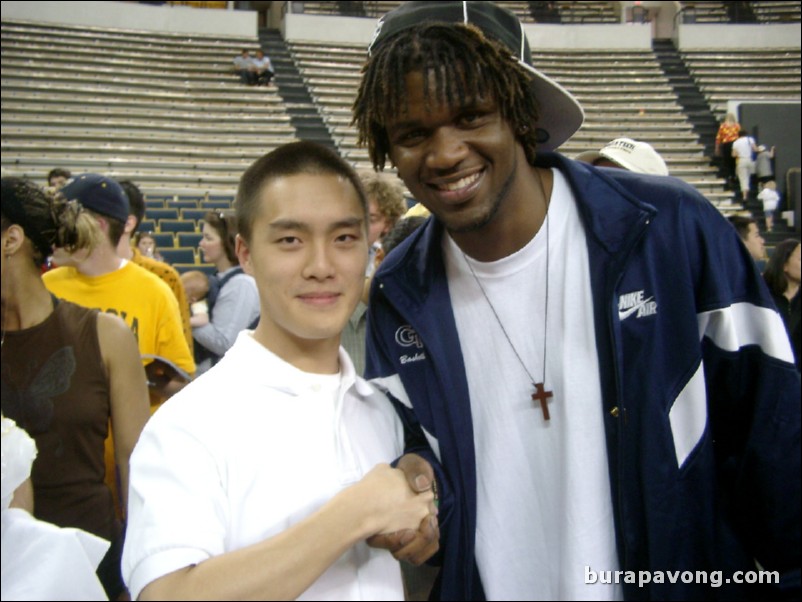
left=235, top=140, right=368, bottom=242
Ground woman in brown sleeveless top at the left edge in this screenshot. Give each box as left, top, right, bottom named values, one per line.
left=0, top=178, right=149, bottom=599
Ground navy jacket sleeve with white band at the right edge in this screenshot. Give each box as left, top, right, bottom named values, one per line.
left=686, top=191, right=802, bottom=580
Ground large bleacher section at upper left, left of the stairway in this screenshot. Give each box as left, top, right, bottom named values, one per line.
left=2, top=21, right=295, bottom=198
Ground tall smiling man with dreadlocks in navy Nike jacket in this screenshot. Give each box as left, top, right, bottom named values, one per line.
left=354, top=2, right=800, bottom=600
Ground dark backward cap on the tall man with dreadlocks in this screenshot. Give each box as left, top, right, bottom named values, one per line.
left=368, top=0, right=585, bottom=150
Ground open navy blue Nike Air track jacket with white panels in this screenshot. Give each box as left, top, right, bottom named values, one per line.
left=366, top=153, right=802, bottom=600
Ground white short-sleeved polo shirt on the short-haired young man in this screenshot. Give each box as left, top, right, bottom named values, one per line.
left=122, top=331, right=404, bottom=600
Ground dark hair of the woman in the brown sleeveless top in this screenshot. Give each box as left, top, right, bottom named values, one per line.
left=0, top=177, right=102, bottom=266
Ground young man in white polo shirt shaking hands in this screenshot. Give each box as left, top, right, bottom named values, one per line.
left=123, top=142, right=436, bottom=600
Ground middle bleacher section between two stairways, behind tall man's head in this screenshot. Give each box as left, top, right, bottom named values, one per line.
left=290, top=42, right=740, bottom=212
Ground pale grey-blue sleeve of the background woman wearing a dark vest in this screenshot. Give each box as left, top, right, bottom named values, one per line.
left=192, top=274, right=259, bottom=355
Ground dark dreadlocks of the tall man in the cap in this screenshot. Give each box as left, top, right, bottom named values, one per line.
left=351, top=23, right=539, bottom=170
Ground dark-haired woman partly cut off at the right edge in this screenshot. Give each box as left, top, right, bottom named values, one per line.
left=763, top=238, right=802, bottom=370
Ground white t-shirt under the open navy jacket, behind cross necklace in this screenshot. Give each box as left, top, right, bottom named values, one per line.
left=444, top=170, right=623, bottom=600
